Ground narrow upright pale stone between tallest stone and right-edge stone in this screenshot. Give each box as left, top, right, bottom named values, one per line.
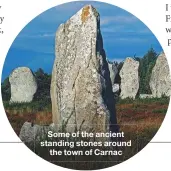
left=119, top=57, right=139, bottom=99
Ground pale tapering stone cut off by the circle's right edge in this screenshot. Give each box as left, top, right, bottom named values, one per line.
left=150, top=53, right=171, bottom=98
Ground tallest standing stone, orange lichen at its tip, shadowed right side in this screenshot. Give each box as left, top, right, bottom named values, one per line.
left=51, top=5, right=117, bottom=132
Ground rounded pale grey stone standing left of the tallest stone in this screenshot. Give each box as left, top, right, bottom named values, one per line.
left=9, top=67, right=37, bottom=103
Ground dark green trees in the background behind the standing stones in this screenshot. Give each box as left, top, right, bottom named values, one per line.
left=1, top=48, right=158, bottom=103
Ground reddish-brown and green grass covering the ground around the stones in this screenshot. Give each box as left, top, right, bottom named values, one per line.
left=4, top=97, right=169, bottom=169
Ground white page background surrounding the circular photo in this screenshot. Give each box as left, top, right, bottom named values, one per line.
left=0, top=0, right=171, bottom=171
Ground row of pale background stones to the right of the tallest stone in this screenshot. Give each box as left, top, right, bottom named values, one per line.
left=109, top=53, right=171, bottom=99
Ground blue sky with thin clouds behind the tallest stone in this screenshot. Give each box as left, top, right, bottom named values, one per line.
left=2, top=1, right=162, bottom=80
